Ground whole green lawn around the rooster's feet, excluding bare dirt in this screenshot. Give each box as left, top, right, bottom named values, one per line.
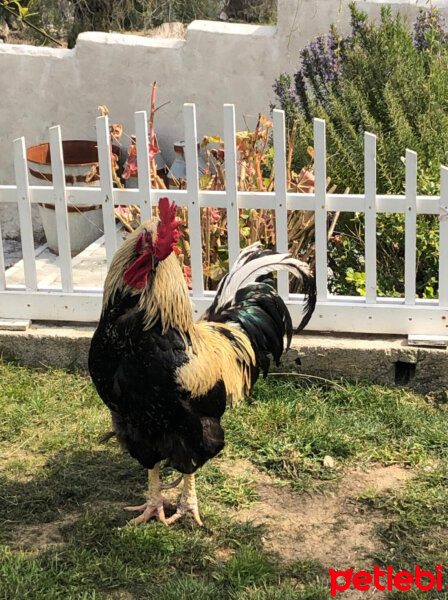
left=0, top=363, right=448, bottom=600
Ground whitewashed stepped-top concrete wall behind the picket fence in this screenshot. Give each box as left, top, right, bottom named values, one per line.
left=0, top=0, right=448, bottom=236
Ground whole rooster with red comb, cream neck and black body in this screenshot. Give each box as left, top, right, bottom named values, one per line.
left=89, top=198, right=316, bottom=525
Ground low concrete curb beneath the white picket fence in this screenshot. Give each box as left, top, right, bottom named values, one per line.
left=0, top=323, right=448, bottom=392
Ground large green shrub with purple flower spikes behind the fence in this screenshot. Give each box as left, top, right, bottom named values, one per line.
left=274, top=4, right=448, bottom=297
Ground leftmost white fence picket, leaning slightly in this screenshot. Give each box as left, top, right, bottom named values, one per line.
left=14, top=137, right=37, bottom=290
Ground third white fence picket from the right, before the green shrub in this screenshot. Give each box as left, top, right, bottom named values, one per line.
left=364, top=132, right=377, bottom=304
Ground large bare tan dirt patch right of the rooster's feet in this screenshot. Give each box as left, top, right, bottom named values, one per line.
left=220, top=460, right=412, bottom=569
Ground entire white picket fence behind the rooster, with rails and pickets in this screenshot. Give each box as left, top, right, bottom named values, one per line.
left=0, top=104, right=448, bottom=336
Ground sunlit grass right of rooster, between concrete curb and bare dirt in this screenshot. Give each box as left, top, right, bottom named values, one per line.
left=226, top=378, right=448, bottom=491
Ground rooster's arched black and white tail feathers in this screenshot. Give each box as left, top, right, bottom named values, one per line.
left=203, top=242, right=316, bottom=374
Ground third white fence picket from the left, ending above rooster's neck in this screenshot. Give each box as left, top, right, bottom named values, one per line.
left=96, top=115, right=117, bottom=267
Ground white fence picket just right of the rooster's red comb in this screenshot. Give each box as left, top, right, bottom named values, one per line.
left=184, top=104, right=204, bottom=296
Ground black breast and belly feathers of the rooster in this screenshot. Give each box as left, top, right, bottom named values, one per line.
left=89, top=294, right=226, bottom=473
